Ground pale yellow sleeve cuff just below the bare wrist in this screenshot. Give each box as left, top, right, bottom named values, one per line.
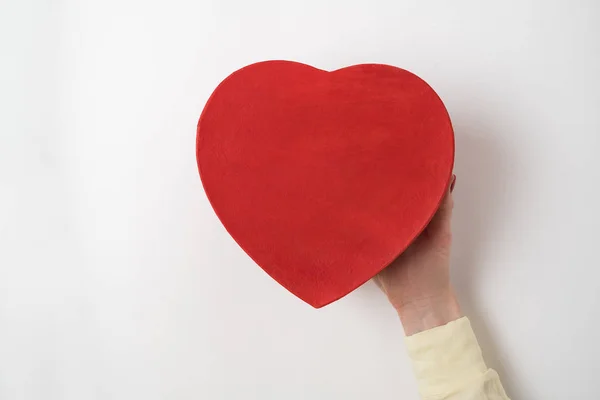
left=405, top=317, right=487, bottom=399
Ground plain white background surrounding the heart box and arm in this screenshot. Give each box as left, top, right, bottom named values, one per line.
left=0, top=0, right=600, bottom=400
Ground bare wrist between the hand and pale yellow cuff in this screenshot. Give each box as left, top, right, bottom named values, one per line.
left=396, top=289, right=463, bottom=336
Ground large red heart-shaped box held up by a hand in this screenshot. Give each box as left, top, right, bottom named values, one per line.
left=196, top=61, right=454, bottom=308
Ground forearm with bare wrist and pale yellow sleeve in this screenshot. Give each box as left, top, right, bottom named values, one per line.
left=397, top=288, right=508, bottom=400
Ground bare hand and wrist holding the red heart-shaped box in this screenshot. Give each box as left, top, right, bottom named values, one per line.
left=373, top=176, right=462, bottom=335
